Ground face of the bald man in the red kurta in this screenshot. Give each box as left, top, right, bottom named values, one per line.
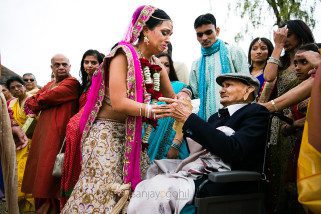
left=51, top=55, right=70, bottom=82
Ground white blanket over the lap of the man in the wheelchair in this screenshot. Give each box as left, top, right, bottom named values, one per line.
left=127, top=127, right=234, bottom=214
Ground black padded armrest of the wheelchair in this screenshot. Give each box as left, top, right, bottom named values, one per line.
left=208, top=170, right=262, bottom=183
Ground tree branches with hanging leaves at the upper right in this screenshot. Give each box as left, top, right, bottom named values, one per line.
left=229, top=0, right=321, bottom=28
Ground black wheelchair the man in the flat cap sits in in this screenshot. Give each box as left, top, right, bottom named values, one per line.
left=194, top=112, right=293, bottom=214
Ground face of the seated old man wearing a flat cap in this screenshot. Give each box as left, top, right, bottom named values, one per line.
left=220, top=79, right=251, bottom=107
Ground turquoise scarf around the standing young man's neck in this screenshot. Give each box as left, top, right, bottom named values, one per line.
left=198, top=39, right=231, bottom=120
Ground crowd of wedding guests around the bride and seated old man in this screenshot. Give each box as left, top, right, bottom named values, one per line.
left=0, top=5, right=321, bottom=214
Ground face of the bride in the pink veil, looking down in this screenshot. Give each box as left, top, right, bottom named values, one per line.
left=145, top=20, right=173, bottom=54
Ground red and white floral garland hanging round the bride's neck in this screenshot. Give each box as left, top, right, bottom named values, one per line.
left=139, top=58, right=162, bottom=149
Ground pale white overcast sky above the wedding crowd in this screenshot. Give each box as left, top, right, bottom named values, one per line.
left=0, top=0, right=321, bottom=86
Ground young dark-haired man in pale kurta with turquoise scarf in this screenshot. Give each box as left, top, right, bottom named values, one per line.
left=189, top=13, right=249, bottom=121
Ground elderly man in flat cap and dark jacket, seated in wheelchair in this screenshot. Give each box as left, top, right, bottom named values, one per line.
left=128, top=73, right=269, bottom=213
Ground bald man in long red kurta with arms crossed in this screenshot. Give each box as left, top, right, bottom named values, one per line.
left=22, top=54, right=79, bottom=213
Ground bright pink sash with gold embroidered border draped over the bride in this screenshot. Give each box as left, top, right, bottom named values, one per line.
left=80, top=41, right=144, bottom=189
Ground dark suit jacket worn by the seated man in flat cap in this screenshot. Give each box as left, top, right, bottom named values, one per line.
left=183, top=103, right=269, bottom=172
